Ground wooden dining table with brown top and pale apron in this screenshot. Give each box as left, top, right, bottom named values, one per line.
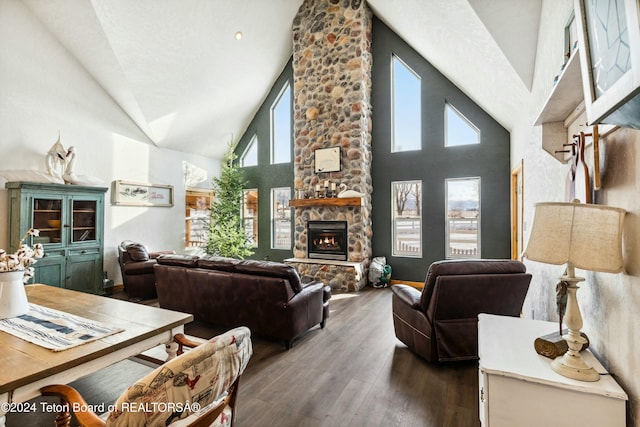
left=0, top=284, right=193, bottom=426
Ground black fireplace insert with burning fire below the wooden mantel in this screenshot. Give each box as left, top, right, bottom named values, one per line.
left=307, top=221, right=347, bottom=261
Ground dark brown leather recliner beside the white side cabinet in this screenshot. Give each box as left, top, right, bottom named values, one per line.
left=391, top=260, right=531, bottom=362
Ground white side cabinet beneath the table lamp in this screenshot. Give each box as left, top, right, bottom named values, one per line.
left=478, top=314, right=627, bottom=427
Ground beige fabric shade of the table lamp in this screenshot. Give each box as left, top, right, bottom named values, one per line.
left=524, top=202, right=626, bottom=273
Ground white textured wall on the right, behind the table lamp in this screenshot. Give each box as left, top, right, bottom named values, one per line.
left=511, top=0, right=640, bottom=426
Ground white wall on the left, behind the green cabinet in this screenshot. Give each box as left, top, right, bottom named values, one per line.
left=0, top=0, right=220, bottom=283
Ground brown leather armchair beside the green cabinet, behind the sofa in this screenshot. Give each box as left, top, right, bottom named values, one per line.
left=118, top=240, right=175, bottom=299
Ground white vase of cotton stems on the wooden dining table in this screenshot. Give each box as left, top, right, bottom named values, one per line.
left=0, top=228, right=44, bottom=319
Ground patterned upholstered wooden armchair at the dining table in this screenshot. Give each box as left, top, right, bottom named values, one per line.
left=41, top=327, right=253, bottom=427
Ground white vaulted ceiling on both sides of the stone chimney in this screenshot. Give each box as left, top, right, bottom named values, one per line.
left=22, top=0, right=542, bottom=158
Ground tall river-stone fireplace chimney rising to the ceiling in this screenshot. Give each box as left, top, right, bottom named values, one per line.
left=286, top=0, right=373, bottom=291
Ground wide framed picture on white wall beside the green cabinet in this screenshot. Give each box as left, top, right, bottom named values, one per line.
left=111, top=181, right=173, bottom=207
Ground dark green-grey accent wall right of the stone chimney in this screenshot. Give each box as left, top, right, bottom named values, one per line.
left=371, top=18, right=511, bottom=281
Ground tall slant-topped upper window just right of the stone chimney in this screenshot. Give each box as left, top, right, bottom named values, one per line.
left=391, top=55, right=422, bottom=153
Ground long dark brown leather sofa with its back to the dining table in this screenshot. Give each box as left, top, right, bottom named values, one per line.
left=154, top=255, right=331, bottom=349
